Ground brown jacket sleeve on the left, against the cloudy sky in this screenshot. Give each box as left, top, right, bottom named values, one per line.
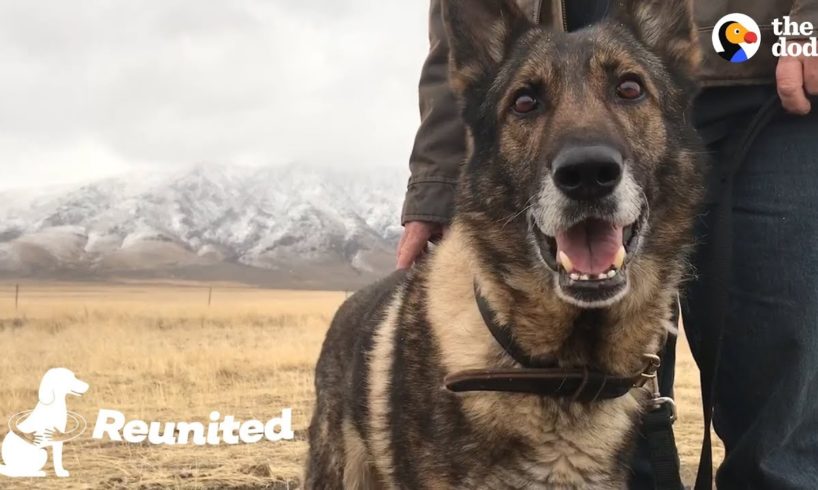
left=401, top=0, right=466, bottom=224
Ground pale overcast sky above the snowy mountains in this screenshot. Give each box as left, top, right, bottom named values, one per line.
left=0, top=0, right=428, bottom=189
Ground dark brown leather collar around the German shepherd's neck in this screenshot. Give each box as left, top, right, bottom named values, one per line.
left=444, top=283, right=660, bottom=402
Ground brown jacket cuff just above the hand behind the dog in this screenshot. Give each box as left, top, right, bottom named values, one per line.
left=400, top=177, right=457, bottom=225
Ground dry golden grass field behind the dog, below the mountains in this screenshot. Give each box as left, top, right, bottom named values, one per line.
left=0, top=283, right=712, bottom=489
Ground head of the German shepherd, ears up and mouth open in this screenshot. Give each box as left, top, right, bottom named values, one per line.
left=443, top=0, right=701, bottom=308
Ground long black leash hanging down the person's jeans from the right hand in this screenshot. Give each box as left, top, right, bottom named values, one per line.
left=694, top=95, right=782, bottom=490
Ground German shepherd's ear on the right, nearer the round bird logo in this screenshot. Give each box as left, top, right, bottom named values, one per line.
left=613, top=0, right=701, bottom=77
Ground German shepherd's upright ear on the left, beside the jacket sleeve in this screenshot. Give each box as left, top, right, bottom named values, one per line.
left=442, top=0, right=532, bottom=94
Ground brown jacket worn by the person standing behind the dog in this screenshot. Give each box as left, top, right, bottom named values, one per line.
left=401, top=0, right=818, bottom=224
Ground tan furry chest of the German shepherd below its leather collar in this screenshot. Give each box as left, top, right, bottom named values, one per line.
left=452, top=394, right=638, bottom=489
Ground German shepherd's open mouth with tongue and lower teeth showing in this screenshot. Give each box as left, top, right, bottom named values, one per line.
left=533, top=207, right=647, bottom=306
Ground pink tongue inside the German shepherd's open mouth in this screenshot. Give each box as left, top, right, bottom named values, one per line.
left=556, top=219, right=622, bottom=275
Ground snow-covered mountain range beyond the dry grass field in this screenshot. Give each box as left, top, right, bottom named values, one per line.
left=0, top=164, right=406, bottom=287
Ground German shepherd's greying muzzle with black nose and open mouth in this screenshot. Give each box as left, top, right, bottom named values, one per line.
left=529, top=145, right=648, bottom=307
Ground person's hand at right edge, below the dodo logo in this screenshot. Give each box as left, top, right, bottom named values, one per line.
left=775, top=45, right=818, bottom=116
